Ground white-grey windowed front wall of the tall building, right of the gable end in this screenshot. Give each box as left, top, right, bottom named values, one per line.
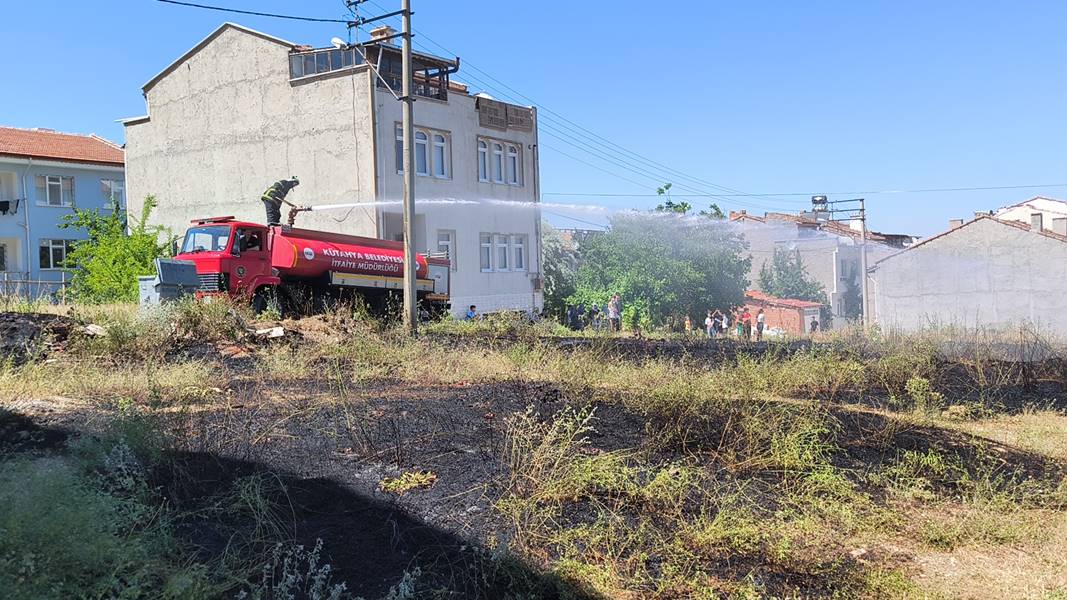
left=376, top=90, right=544, bottom=316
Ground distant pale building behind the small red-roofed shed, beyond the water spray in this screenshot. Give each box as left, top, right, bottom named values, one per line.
left=730, top=210, right=914, bottom=327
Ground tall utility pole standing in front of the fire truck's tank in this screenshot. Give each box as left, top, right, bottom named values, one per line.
left=401, top=0, right=418, bottom=334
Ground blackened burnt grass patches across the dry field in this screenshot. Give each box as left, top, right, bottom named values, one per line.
left=0, top=309, right=1062, bottom=599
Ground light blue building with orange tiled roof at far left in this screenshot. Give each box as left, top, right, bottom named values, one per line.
left=0, top=127, right=126, bottom=296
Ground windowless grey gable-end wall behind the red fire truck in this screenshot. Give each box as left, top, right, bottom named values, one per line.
left=126, top=28, right=378, bottom=236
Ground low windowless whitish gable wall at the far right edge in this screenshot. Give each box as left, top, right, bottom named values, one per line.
left=872, top=219, right=1067, bottom=336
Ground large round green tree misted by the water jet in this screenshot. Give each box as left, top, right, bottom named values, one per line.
left=571, top=215, right=750, bottom=328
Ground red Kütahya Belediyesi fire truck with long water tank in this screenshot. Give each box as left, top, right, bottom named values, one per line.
left=148, top=217, right=450, bottom=313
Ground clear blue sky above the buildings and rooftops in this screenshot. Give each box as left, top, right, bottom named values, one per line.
left=0, top=0, right=1067, bottom=235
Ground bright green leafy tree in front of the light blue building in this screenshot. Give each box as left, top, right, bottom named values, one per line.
left=60, top=195, right=172, bottom=302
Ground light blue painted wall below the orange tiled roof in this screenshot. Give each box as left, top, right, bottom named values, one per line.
left=0, top=157, right=124, bottom=295
